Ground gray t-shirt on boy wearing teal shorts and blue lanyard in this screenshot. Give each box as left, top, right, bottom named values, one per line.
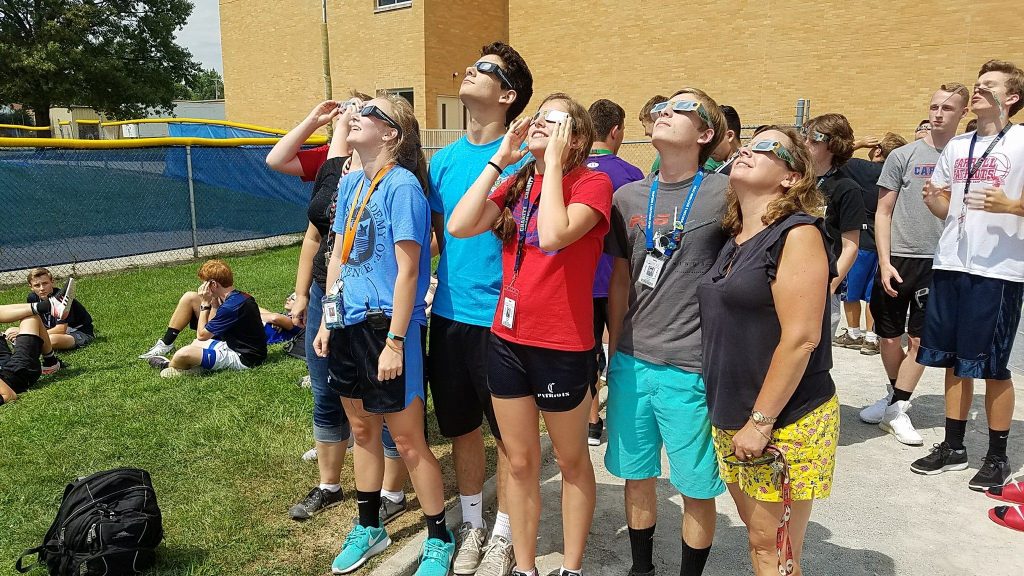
left=604, top=169, right=729, bottom=373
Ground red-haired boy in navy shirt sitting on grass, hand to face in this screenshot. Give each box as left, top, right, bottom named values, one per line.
left=139, top=259, right=266, bottom=378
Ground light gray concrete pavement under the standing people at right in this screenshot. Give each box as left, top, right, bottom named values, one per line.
left=538, top=342, right=1024, bottom=576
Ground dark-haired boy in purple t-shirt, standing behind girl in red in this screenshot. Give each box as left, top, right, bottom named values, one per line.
left=587, top=99, right=644, bottom=446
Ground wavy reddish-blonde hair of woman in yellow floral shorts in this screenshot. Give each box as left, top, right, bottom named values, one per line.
left=722, top=126, right=825, bottom=236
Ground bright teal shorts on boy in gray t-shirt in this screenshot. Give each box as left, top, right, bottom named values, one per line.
left=604, top=352, right=725, bottom=499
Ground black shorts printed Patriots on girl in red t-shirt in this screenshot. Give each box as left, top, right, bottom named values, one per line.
left=487, top=333, right=597, bottom=412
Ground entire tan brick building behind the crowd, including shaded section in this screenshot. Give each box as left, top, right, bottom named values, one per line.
left=220, top=0, right=1024, bottom=137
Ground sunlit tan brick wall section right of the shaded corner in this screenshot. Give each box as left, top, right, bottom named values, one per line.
left=509, top=0, right=1024, bottom=138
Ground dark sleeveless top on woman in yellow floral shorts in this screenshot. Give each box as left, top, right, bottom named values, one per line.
left=697, top=212, right=836, bottom=429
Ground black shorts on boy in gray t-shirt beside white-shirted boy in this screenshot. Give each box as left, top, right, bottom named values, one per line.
left=869, top=256, right=932, bottom=338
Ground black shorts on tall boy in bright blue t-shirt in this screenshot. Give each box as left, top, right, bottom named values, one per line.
left=427, top=315, right=501, bottom=439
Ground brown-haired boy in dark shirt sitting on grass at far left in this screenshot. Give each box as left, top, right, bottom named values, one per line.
left=4, top=268, right=95, bottom=351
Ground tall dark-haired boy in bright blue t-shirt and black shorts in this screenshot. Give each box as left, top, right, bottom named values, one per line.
left=428, top=42, right=534, bottom=574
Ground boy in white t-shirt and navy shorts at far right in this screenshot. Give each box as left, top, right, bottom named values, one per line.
left=910, top=60, right=1024, bottom=491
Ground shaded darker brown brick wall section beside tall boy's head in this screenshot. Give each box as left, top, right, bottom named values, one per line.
left=425, top=0, right=508, bottom=128
